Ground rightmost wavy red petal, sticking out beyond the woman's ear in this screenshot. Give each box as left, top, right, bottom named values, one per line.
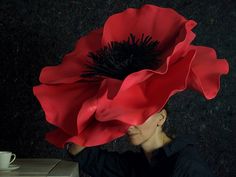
left=188, top=46, right=229, bottom=99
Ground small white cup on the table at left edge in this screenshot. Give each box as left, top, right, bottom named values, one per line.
left=0, top=151, right=16, bottom=169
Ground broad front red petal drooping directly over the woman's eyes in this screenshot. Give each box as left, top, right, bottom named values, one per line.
left=95, top=50, right=195, bottom=125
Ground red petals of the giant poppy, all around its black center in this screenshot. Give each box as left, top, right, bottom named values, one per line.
left=33, top=4, right=229, bottom=147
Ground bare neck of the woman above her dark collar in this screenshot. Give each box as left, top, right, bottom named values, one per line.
left=141, top=129, right=171, bottom=162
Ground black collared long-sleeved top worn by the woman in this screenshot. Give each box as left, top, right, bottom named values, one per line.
left=68, top=136, right=213, bottom=177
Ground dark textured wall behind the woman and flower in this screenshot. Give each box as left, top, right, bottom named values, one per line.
left=0, top=0, right=236, bottom=177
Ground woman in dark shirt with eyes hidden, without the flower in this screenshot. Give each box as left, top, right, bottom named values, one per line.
left=68, top=109, right=216, bottom=177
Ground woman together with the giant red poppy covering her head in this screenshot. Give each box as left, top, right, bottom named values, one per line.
left=33, top=4, right=229, bottom=177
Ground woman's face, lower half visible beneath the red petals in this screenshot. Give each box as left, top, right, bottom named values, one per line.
left=127, top=110, right=162, bottom=145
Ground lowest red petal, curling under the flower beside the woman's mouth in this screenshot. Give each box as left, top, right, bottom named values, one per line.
left=46, top=92, right=128, bottom=148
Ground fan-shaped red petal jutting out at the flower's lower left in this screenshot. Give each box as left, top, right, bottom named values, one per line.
left=33, top=81, right=100, bottom=135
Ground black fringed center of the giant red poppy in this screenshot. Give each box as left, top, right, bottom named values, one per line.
left=81, top=33, right=161, bottom=80
